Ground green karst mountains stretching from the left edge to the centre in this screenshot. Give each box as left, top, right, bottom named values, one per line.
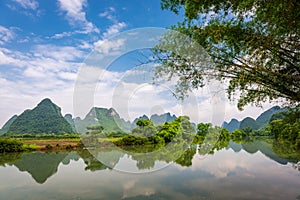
left=0, top=98, right=176, bottom=135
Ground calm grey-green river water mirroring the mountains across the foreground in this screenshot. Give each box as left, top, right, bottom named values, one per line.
left=0, top=141, right=300, bottom=200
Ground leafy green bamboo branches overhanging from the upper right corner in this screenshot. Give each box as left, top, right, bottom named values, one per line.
left=154, top=0, right=300, bottom=109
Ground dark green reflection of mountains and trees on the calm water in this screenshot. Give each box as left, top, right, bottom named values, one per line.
left=0, top=140, right=300, bottom=184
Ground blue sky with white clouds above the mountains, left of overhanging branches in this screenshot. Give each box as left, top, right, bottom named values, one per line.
left=0, top=0, right=273, bottom=126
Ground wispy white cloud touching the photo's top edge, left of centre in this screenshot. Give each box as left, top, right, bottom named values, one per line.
left=58, top=0, right=100, bottom=33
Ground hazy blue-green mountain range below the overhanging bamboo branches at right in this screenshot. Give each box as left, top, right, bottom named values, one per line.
left=222, top=106, right=286, bottom=132
